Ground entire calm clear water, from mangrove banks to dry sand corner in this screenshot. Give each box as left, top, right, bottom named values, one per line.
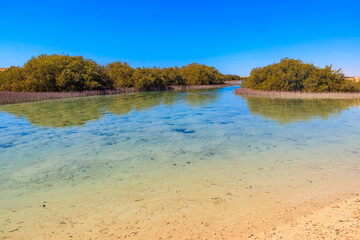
left=0, top=87, right=360, bottom=239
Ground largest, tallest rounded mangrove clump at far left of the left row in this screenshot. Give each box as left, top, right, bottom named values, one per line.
left=0, top=55, right=112, bottom=92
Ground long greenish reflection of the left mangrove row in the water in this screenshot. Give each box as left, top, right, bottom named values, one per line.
left=0, top=89, right=218, bottom=127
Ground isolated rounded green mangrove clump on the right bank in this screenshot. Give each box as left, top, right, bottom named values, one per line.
left=241, top=58, right=360, bottom=92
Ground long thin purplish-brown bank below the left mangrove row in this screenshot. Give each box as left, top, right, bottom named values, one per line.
left=0, top=81, right=238, bottom=105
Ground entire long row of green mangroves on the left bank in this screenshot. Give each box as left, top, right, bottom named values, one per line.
left=0, top=54, right=239, bottom=92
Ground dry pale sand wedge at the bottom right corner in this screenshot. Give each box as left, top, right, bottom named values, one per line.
left=250, top=197, right=360, bottom=239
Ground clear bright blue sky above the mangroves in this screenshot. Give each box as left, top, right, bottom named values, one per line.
left=0, top=0, right=360, bottom=75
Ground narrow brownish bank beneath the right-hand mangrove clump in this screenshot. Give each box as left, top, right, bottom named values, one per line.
left=235, top=88, right=360, bottom=99
